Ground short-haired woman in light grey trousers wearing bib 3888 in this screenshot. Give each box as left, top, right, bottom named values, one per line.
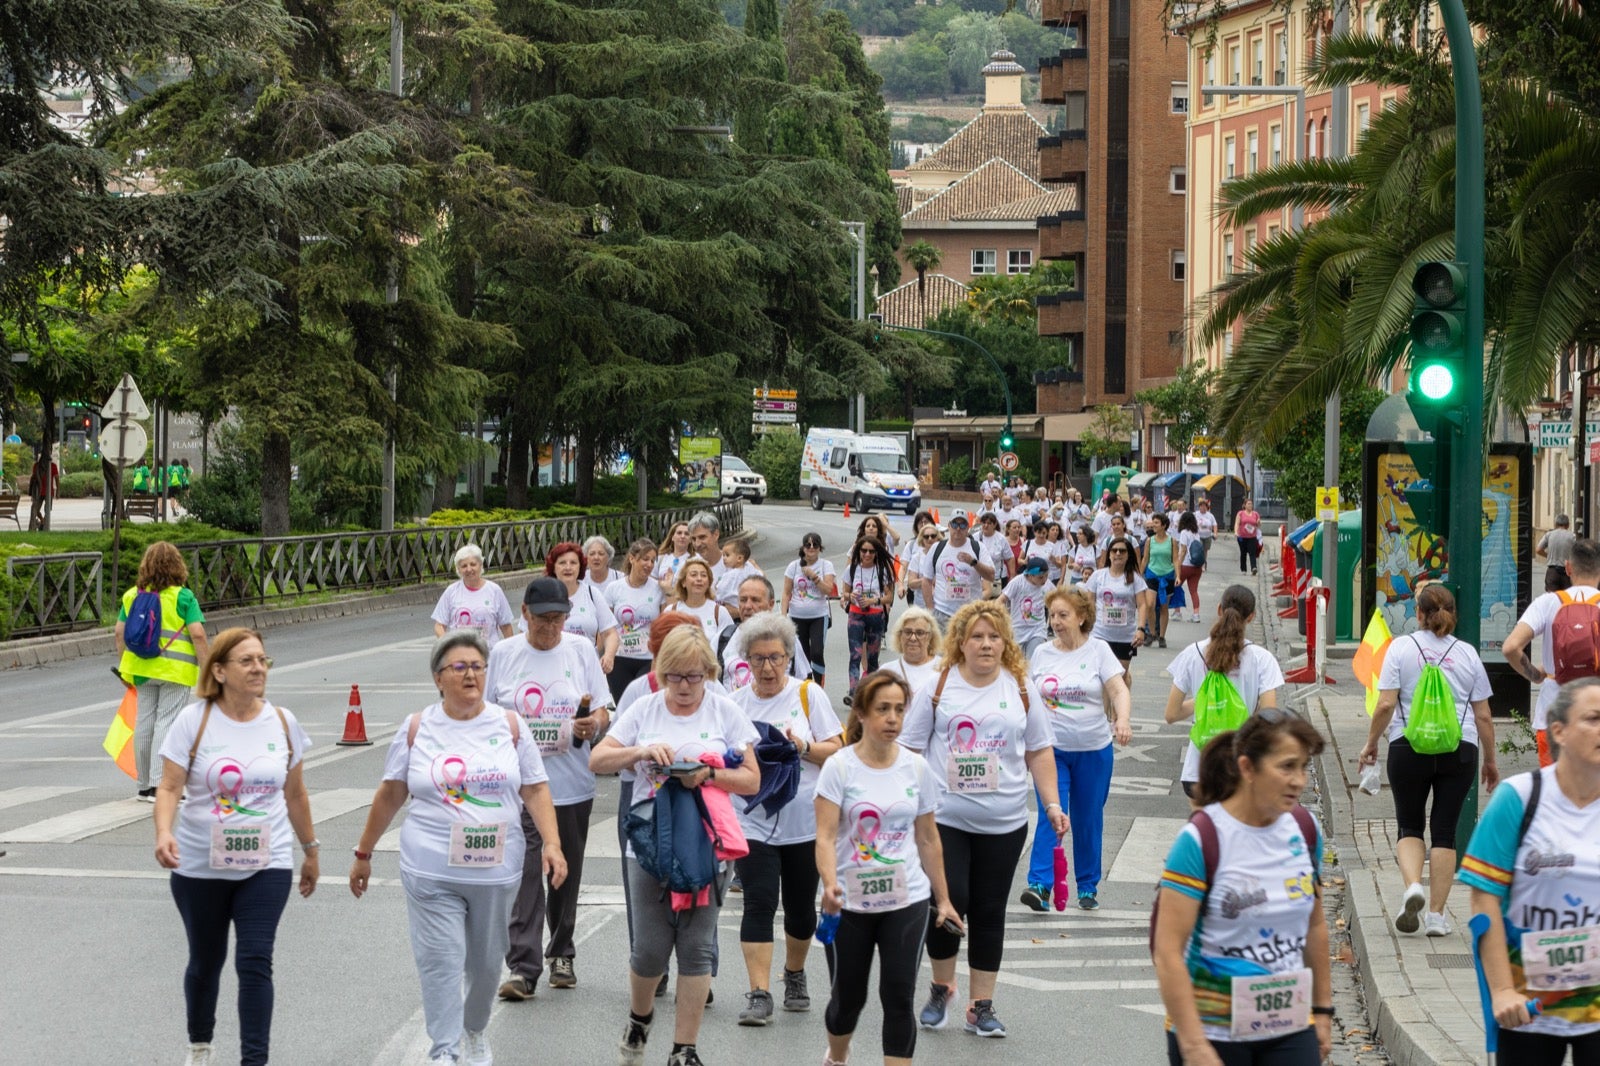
left=350, top=632, right=566, bottom=1063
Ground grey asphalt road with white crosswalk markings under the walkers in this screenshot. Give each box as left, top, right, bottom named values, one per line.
left=0, top=503, right=1234, bottom=1066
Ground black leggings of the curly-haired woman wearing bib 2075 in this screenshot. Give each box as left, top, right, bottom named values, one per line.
left=928, top=824, right=1027, bottom=973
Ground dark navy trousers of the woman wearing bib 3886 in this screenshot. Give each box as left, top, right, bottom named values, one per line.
left=171, top=869, right=294, bottom=1066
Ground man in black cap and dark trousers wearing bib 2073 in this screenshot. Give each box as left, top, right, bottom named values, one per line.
left=483, top=578, right=611, bottom=1000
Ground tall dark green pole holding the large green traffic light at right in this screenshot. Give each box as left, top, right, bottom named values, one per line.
left=1438, top=0, right=1484, bottom=853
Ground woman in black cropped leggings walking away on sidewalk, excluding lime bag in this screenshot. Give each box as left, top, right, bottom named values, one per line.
left=1360, top=584, right=1499, bottom=936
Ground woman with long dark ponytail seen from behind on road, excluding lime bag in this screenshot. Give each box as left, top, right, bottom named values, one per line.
left=1166, top=584, right=1283, bottom=797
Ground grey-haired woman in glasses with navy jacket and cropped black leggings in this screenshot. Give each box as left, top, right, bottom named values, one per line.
left=733, top=611, right=845, bottom=1026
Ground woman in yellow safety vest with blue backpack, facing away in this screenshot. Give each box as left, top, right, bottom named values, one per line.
left=117, top=541, right=206, bottom=804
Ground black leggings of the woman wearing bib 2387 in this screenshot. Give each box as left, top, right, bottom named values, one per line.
left=822, top=900, right=928, bottom=1058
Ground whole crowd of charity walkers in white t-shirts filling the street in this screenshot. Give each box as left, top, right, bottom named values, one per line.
left=103, top=483, right=1600, bottom=1066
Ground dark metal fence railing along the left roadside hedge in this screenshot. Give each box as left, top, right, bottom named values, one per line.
left=6, top=499, right=744, bottom=637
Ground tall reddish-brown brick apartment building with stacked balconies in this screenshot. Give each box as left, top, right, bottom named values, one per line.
left=1038, top=0, right=1189, bottom=472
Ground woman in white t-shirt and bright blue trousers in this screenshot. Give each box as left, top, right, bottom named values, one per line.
left=1022, top=586, right=1133, bottom=911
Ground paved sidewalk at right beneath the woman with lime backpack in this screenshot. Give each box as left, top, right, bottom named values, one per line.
left=1261, top=567, right=1538, bottom=1066
